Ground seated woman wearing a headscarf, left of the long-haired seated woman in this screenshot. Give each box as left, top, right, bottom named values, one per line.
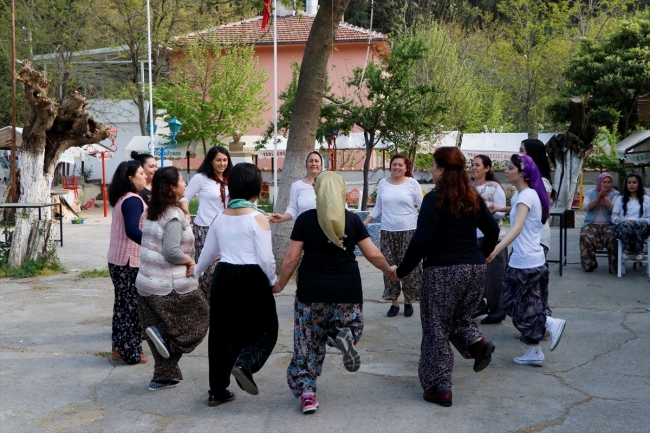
left=580, top=173, right=619, bottom=274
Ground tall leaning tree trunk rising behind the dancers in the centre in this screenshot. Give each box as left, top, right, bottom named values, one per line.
left=272, top=0, right=350, bottom=271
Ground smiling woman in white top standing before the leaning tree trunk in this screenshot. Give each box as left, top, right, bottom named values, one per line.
left=270, top=150, right=323, bottom=223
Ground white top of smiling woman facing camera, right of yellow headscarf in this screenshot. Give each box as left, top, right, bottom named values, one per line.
left=369, top=177, right=423, bottom=232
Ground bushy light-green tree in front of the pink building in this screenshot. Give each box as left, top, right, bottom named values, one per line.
left=154, top=40, right=268, bottom=155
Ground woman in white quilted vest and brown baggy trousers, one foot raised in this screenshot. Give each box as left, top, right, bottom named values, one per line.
left=135, top=167, right=210, bottom=391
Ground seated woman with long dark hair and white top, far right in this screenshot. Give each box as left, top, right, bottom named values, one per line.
left=612, top=173, right=650, bottom=261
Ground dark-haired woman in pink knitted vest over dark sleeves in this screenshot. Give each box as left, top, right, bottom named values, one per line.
left=108, top=161, right=147, bottom=364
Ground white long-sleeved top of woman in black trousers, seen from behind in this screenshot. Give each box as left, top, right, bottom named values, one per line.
left=194, top=212, right=276, bottom=286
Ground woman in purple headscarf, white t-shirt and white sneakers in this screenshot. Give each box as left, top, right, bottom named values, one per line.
left=487, top=155, right=566, bottom=365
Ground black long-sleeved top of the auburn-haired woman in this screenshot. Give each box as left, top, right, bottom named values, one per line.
left=397, top=191, right=499, bottom=278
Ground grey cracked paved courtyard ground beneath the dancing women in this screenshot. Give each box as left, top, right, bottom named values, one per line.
left=0, top=209, right=650, bottom=433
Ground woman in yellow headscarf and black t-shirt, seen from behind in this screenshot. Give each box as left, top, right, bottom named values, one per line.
left=273, top=172, right=392, bottom=413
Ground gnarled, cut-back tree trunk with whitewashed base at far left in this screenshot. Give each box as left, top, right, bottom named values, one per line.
left=9, top=62, right=108, bottom=267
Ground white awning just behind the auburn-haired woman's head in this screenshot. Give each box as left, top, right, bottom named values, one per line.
left=460, top=133, right=528, bottom=161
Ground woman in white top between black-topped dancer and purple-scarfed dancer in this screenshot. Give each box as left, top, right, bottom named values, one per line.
left=472, top=155, right=508, bottom=325
